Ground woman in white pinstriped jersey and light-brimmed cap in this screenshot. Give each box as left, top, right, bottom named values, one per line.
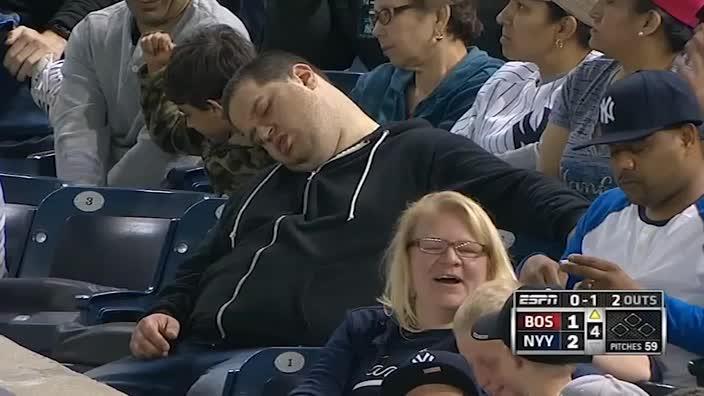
left=451, top=0, right=600, bottom=169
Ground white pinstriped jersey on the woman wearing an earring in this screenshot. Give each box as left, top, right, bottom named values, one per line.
left=451, top=51, right=601, bottom=169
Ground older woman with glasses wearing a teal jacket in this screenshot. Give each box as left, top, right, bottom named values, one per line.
left=350, top=0, right=503, bottom=129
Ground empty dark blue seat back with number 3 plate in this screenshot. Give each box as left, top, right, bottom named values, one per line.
left=14, top=187, right=203, bottom=290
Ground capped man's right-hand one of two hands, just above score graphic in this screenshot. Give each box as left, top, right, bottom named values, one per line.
left=560, top=254, right=641, bottom=290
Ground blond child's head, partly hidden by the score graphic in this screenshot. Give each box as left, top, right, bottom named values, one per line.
left=453, top=280, right=574, bottom=395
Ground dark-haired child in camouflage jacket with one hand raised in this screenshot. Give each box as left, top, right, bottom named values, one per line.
left=139, top=25, right=273, bottom=196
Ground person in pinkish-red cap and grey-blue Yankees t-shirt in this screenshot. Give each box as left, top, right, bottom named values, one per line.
left=538, top=0, right=704, bottom=199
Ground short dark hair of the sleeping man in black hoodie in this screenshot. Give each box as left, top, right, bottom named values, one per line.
left=222, top=50, right=327, bottom=120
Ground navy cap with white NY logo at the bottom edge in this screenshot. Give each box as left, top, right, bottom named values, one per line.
left=381, top=350, right=479, bottom=396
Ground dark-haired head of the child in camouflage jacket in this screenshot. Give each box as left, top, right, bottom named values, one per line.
left=164, top=25, right=255, bottom=141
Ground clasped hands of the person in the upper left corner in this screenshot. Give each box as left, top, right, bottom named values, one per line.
left=3, top=26, right=66, bottom=81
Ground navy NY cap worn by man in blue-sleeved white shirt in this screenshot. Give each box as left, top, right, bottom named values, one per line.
left=574, top=70, right=702, bottom=150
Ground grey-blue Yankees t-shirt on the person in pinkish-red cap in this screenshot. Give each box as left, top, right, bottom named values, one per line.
left=550, top=56, right=620, bottom=201
